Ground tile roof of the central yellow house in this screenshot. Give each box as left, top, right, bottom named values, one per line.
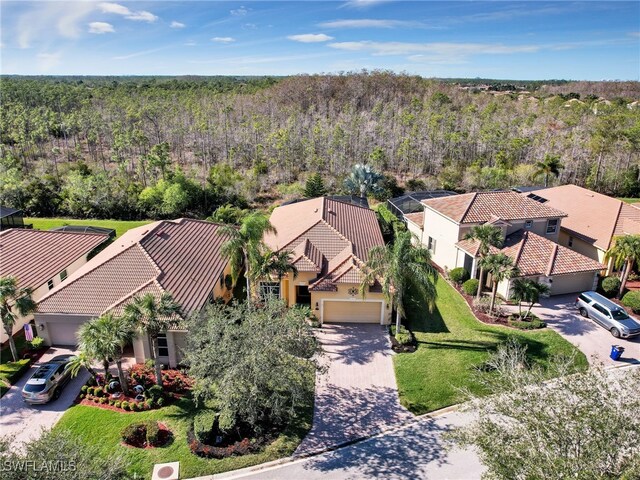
left=265, top=197, right=384, bottom=290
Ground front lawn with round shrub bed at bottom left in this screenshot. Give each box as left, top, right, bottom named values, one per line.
left=55, top=398, right=313, bottom=478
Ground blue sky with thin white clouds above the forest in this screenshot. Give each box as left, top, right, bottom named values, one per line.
left=0, top=0, right=640, bottom=80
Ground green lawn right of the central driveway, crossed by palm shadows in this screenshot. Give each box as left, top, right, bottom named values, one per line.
left=394, top=278, right=587, bottom=414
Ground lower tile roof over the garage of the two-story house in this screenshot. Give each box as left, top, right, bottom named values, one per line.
left=456, top=230, right=605, bottom=276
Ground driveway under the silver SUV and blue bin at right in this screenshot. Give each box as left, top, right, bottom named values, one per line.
left=510, top=294, right=640, bottom=366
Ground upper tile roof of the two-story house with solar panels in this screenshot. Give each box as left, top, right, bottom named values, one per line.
left=422, top=191, right=566, bottom=223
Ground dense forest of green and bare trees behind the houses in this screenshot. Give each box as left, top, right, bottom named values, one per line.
left=0, top=72, right=640, bottom=218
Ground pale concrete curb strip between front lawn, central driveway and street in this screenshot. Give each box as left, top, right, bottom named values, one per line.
left=188, top=404, right=460, bottom=480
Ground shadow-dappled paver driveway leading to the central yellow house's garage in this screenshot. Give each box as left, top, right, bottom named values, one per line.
left=296, top=324, right=414, bottom=454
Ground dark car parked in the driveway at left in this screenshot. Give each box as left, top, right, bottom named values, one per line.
left=22, top=355, right=73, bottom=404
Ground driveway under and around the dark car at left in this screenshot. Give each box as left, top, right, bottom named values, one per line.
left=0, top=347, right=89, bottom=445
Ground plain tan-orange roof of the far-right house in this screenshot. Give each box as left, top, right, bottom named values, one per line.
left=525, top=185, right=640, bottom=250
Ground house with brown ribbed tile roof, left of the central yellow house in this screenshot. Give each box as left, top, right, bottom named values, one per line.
left=35, top=219, right=231, bottom=367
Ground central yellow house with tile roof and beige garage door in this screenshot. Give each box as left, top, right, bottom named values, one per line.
left=260, top=197, right=391, bottom=324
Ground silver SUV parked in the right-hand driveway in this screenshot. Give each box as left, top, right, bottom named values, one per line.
left=576, top=292, right=640, bottom=338
